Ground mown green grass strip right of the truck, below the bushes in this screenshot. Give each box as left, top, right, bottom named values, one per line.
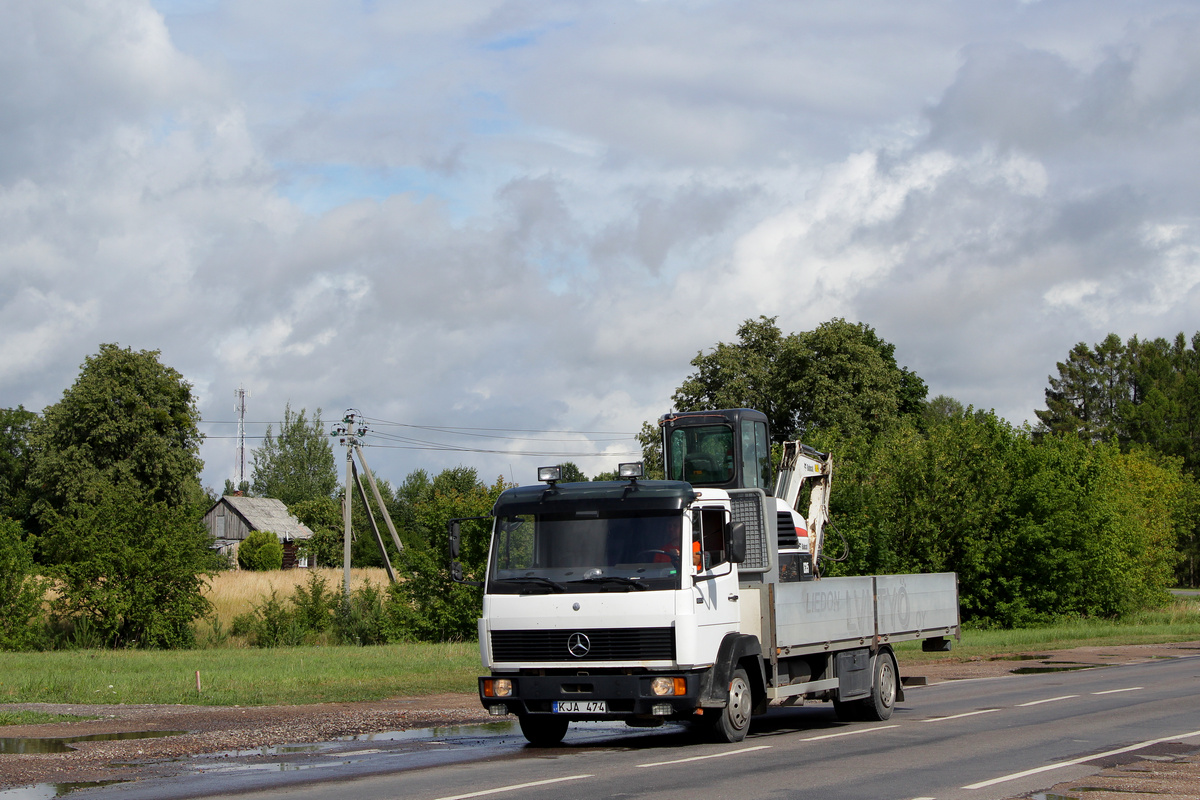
left=896, top=597, right=1200, bottom=664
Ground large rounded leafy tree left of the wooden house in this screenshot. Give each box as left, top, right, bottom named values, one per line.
left=29, top=344, right=216, bottom=646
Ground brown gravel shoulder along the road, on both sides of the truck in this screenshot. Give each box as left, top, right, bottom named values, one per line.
left=0, top=642, right=1200, bottom=800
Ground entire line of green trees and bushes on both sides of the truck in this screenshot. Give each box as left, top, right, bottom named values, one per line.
left=0, top=326, right=1200, bottom=649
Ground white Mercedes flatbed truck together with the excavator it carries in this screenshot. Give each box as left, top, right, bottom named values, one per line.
left=450, top=409, right=959, bottom=746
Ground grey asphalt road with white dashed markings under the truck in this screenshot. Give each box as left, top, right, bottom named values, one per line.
left=80, top=657, right=1200, bottom=800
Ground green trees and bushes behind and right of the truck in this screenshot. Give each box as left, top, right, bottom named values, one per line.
left=662, top=317, right=1200, bottom=626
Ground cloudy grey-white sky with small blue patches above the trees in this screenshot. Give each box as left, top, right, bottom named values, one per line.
left=0, top=0, right=1200, bottom=489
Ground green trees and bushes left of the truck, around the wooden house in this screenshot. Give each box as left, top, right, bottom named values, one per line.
left=0, top=344, right=505, bottom=649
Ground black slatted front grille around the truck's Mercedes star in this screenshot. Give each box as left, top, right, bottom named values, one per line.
left=491, top=627, right=674, bottom=662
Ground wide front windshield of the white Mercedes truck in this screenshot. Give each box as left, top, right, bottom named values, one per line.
left=487, top=511, right=690, bottom=594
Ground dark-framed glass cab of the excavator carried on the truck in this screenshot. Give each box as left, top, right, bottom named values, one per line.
left=659, top=408, right=774, bottom=495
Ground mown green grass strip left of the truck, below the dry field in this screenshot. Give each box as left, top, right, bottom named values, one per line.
left=0, top=642, right=480, bottom=705
